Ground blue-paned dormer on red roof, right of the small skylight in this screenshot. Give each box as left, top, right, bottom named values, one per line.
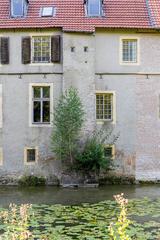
left=87, top=0, right=102, bottom=17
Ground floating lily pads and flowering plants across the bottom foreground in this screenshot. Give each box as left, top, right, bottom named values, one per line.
left=0, top=198, right=160, bottom=240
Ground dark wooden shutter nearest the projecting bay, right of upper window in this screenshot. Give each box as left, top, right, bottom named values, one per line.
left=51, top=35, right=61, bottom=63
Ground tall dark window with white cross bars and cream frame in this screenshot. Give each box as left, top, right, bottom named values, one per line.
left=29, top=83, right=53, bottom=127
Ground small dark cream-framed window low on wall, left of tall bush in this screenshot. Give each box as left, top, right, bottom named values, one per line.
left=24, top=148, right=38, bottom=164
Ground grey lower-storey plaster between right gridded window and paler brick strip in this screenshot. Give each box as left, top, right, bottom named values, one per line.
left=96, top=76, right=136, bottom=175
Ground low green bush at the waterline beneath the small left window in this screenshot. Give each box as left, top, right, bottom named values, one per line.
left=18, top=175, right=46, bottom=187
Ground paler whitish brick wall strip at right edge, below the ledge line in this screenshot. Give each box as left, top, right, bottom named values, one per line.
left=136, top=76, right=160, bottom=180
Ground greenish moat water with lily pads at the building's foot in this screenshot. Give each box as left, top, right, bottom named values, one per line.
left=0, top=185, right=160, bottom=240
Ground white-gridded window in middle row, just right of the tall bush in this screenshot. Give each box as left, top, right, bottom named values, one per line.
left=96, top=93, right=113, bottom=121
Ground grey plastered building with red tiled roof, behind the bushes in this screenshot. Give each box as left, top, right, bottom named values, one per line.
left=0, top=0, right=160, bottom=180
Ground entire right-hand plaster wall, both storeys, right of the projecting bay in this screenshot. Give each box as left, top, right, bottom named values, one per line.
left=96, top=31, right=160, bottom=180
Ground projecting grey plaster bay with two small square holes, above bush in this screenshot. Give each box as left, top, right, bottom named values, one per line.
left=63, top=34, right=95, bottom=132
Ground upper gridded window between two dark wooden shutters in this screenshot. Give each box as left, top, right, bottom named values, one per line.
left=32, top=36, right=51, bottom=63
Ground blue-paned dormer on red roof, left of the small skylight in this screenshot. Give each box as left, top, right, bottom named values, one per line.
left=11, top=0, right=28, bottom=17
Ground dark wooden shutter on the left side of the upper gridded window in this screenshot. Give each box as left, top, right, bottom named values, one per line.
left=22, top=37, right=31, bottom=64
